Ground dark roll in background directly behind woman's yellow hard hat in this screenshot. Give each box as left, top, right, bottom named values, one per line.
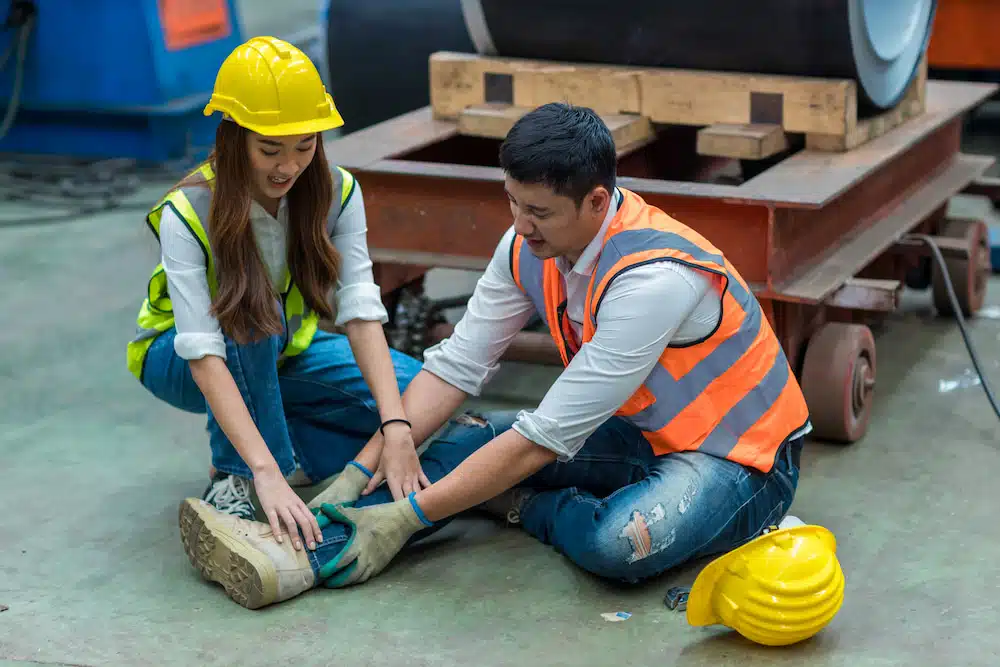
left=326, top=0, right=475, bottom=133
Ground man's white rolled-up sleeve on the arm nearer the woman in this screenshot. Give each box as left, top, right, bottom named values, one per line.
left=423, top=227, right=535, bottom=396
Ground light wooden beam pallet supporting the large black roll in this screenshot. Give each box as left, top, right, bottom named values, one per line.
left=430, top=52, right=927, bottom=159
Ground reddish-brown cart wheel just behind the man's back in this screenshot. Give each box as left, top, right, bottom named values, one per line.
left=801, top=322, right=875, bottom=444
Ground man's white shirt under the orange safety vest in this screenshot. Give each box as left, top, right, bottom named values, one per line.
left=424, top=189, right=722, bottom=461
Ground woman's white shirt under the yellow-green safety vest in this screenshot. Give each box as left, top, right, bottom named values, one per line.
left=160, top=182, right=389, bottom=359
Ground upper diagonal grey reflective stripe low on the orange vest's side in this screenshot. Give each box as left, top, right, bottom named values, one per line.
left=629, top=296, right=764, bottom=431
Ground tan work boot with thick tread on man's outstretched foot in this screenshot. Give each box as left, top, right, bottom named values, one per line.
left=179, top=498, right=316, bottom=609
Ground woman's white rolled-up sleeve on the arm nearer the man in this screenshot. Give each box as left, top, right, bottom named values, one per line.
left=330, top=181, right=389, bottom=326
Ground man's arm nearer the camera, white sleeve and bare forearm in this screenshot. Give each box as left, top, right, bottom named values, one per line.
left=414, top=262, right=711, bottom=521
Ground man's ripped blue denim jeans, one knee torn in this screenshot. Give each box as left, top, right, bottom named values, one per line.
left=310, top=412, right=802, bottom=583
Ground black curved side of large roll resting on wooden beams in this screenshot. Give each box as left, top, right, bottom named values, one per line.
left=481, top=0, right=933, bottom=111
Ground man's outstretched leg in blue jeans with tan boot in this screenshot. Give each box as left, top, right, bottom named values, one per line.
left=180, top=404, right=511, bottom=609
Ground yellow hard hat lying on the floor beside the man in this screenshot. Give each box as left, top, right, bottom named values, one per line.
left=687, top=525, right=844, bottom=646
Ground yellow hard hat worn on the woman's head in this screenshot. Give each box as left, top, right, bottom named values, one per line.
left=204, top=37, right=344, bottom=136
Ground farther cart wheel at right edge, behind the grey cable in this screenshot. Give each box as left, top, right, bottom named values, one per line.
left=931, top=220, right=993, bottom=317
